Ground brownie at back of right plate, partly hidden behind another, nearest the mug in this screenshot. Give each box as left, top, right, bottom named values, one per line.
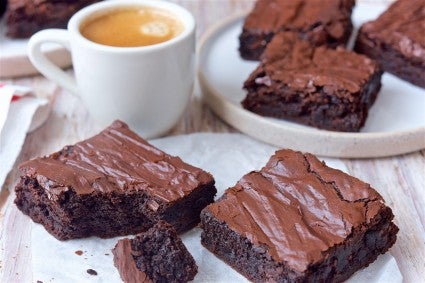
left=239, top=0, right=355, bottom=60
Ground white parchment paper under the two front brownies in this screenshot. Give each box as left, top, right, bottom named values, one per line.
left=31, top=134, right=402, bottom=283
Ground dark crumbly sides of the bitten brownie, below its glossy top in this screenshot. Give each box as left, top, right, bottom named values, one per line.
left=15, top=176, right=217, bottom=240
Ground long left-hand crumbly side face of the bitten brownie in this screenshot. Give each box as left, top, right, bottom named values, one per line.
left=15, top=177, right=153, bottom=240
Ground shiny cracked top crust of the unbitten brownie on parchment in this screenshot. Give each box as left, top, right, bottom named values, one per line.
left=208, top=150, right=385, bottom=271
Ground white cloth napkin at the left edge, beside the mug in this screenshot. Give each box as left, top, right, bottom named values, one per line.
left=0, top=83, right=49, bottom=189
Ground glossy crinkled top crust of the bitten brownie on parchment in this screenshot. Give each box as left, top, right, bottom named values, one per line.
left=19, top=121, right=212, bottom=203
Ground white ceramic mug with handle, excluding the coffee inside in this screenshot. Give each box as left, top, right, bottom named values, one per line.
left=28, top=0, right=195, bottom=138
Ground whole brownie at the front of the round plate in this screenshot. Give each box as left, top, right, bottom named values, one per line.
left=242, top=32, right=382, bottom=132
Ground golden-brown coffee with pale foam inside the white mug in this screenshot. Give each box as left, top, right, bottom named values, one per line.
left=80, top=6, right=184, bottom=47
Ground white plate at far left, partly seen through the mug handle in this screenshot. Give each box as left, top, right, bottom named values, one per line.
left=0, top=19, right=71, bottom=78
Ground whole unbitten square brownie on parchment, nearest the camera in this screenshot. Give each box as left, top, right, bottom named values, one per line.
left=201, top=150, right=398, bottom=282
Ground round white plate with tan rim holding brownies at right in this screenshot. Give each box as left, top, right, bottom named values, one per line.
left=198, top=3, right=425, bottom=158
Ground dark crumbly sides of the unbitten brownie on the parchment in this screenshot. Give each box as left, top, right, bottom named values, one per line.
left=201, top=207, right=398, bottom=282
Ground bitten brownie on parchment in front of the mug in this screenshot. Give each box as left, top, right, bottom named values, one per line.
left=15, top=121, right=216, bottom=240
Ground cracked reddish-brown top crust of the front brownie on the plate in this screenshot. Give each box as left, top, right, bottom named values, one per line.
left=244, top=32, right=380, bottom=93
